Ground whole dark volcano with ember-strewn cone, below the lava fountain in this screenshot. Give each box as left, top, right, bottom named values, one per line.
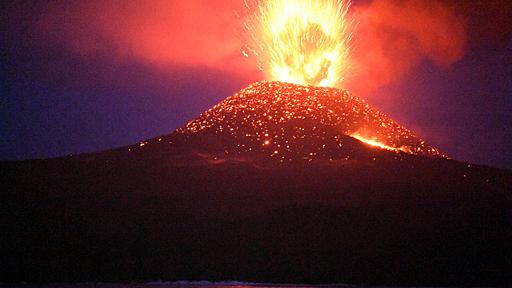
left=0, top=82, right=512, bottom=286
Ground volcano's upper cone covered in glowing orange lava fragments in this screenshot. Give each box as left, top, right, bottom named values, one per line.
left=171, top=82, right=446, bottom=161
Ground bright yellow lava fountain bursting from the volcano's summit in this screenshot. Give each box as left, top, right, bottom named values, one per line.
left=244, top=0, right=354, bottom=87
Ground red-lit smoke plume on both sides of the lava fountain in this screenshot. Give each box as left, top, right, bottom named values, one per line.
left=38, top=0, right=466, bottom=95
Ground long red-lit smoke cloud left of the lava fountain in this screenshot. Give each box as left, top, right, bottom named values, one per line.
left=36, top=0, right=256, bottom=76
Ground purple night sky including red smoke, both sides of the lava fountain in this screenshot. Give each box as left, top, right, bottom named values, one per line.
left=0, top=0, right=512, bottom=168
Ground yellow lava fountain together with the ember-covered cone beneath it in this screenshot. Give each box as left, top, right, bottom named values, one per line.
left=130, top=0, right=446, bottom=162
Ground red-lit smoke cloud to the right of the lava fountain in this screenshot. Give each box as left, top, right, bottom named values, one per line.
left=347, top=0, right=467, bottom=95
